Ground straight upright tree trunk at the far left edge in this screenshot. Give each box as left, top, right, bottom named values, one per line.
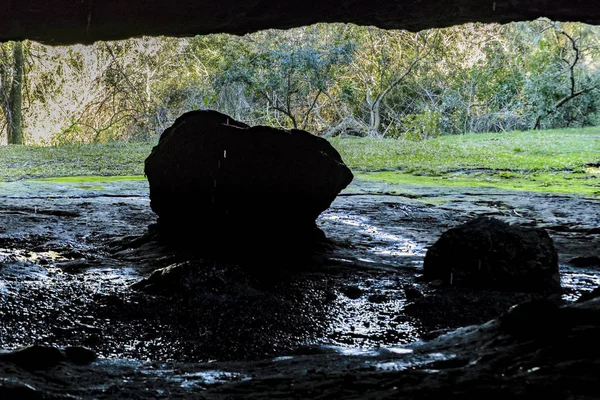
left=7, top=42, right=23, bottom=144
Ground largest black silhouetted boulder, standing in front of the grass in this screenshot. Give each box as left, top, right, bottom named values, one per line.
left=145, top=111, right=353, bottom=244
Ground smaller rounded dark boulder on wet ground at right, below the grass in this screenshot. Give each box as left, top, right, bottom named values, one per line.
left=423, top=217, right=560, bottom=292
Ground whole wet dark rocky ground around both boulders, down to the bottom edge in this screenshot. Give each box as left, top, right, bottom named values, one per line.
left=0, top=181, right=600, bottom=398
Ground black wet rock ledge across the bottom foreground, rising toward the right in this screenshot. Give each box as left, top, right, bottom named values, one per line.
left=0, top=299, right=600, bottom=399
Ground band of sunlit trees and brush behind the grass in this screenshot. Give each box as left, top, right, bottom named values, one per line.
left=0, top=19, right=600, bottom=144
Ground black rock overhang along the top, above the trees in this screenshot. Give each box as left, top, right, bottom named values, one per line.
left=0, top=0, right=600, bottom=44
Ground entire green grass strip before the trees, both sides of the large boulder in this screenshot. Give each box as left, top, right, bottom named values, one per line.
left=0, top=128, right=600, bottom=197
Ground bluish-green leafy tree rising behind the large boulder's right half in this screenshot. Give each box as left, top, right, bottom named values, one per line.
left=217, top=25, right=354, bottom=129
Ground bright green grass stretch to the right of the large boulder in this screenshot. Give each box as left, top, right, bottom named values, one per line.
left=331, top=128, right=600, bottom=197
